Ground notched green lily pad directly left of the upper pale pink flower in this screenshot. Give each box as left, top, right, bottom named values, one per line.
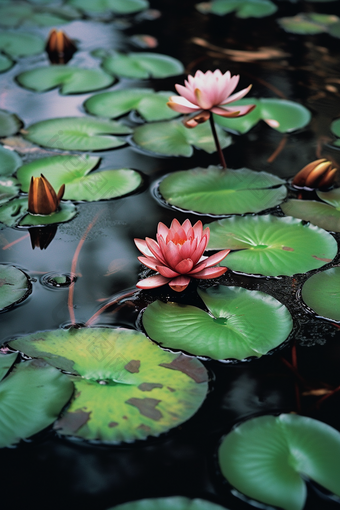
left=84, top=89, right=178, bottom=122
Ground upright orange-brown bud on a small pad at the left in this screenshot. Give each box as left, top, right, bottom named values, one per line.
left=28, top=174, right=65, bottom=215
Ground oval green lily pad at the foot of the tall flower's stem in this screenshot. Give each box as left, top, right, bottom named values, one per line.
left=159, top=166, right=287, bottom=215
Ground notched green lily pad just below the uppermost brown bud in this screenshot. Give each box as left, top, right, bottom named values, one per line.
left=17, top=65, right=114, bottom=94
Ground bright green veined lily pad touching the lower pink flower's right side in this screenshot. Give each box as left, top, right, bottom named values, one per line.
left=207, top=215, right=337, bottom=276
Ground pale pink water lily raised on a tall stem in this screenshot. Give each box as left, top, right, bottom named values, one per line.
left=167, top=69, right=256, bottom=127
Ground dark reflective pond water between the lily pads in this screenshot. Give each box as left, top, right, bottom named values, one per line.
left=0, top=0, right=340, bottom=510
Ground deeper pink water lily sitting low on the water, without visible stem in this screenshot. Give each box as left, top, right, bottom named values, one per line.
left=135, top=219, right=230, bottom=292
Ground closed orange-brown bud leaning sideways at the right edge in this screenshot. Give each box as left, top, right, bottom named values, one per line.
left=292, top=158, right=337, bottom=189
